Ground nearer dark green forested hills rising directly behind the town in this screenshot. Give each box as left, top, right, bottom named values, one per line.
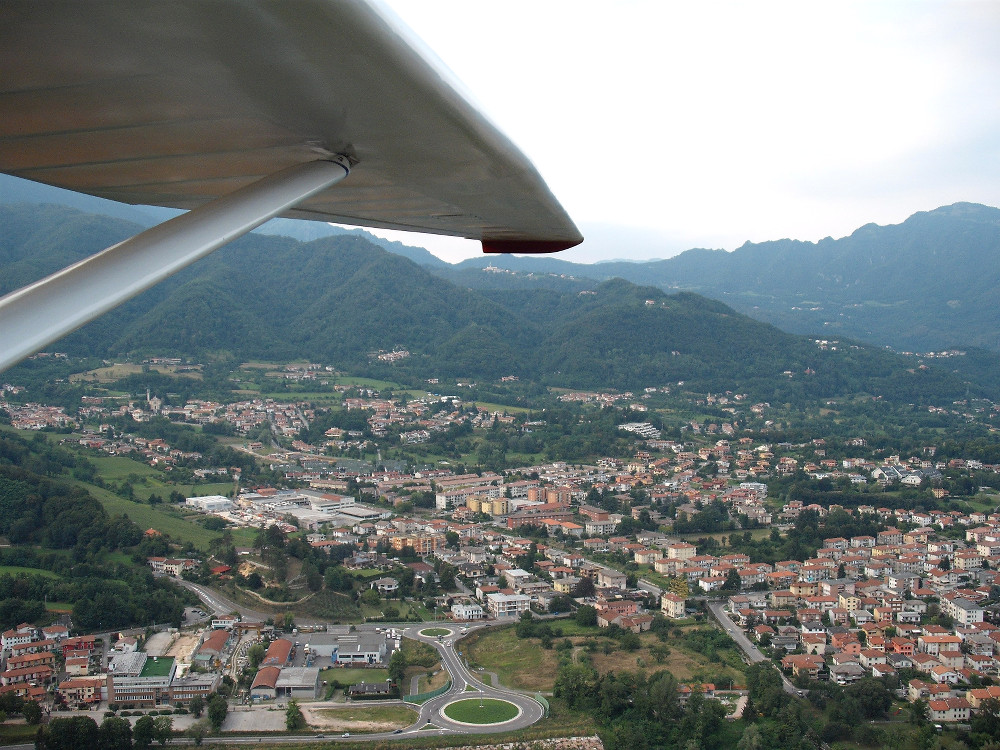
left=0, top=204, right=1000, bottom=403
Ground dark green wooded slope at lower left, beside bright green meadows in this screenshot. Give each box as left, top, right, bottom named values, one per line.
left=0, top=431, right=188, bottom=629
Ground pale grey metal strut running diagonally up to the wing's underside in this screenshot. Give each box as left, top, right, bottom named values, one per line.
left=0, top=156, right=351, bottom=372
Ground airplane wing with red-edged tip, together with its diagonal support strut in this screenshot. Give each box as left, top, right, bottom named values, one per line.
left=0, top=0, right=583, bottom=369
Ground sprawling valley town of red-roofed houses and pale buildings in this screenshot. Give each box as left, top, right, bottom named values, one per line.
left=0, top=356, right=1000, bottom=748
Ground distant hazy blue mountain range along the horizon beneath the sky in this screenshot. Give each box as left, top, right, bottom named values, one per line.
left=0, top=175, right=1000, bottom=352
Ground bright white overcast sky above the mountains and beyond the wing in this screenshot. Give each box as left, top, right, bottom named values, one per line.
left=352, top=0, right=1000, bottom=261
